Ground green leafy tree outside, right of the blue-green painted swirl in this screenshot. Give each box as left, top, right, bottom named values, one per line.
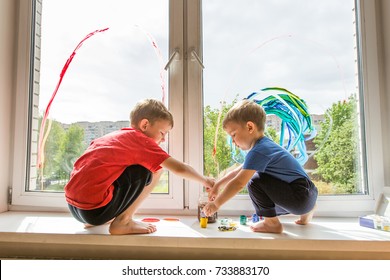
left=314, top=97, right=359, bottom=193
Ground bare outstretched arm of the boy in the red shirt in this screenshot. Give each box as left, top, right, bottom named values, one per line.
left=161, top=157, right=214, bottom=188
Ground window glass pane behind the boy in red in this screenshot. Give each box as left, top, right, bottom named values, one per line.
left=28, top=0, right=168, bottom=193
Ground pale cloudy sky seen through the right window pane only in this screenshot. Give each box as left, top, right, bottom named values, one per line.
left=204, top=0, right=356, bottom=114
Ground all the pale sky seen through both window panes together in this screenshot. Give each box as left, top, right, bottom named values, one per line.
left=39, top=0, right=357, bottom=123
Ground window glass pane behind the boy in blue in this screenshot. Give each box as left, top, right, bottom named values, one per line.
left=203, top=0, right=367, bottom=195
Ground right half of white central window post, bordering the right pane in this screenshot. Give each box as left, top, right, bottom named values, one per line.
left=184, top=0, right=203, bottom=210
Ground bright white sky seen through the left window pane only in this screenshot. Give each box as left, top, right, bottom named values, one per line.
left=39, top=0, right=168, bottom=123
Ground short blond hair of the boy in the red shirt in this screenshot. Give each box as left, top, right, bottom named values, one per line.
left=130, top=99, right=173, bottom=127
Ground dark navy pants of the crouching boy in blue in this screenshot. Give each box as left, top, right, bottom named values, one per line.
left=247, top=172, right=318, bottom=217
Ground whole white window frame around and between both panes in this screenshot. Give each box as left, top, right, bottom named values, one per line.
left=10, top=0, right=385, bottom=216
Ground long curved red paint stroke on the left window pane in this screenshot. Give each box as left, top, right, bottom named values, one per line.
left=37, top=28, right=108, bottom=168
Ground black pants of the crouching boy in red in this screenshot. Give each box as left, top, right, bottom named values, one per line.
left=68, top=165, right=152, bottom=226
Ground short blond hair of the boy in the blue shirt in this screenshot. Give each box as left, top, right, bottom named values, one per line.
left=222, top=99, right=266, bottom=131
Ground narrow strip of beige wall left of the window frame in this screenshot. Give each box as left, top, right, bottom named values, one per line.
left=0, top=0, right=17, bottom=212
